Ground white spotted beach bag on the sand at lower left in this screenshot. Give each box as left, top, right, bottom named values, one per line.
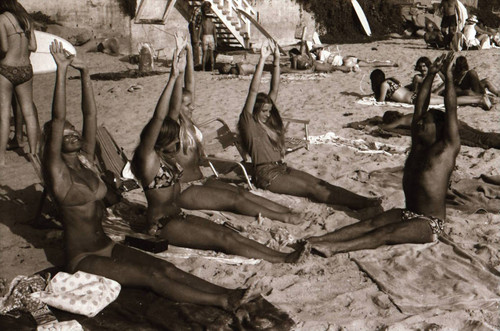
left=31, top=271, right=121, bottom=317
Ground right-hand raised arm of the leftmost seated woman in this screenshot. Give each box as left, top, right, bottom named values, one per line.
left=71, top=58, right=97, bottom=160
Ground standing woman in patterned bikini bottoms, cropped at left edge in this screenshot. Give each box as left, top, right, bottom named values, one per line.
left=0, top=0, right=40, bottom=166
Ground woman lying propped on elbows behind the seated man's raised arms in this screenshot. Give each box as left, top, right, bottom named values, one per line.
left=370, top=69, right=492, bottom=110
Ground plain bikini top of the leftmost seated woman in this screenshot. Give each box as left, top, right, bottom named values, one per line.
left=61, top=156, right=107, bottom=206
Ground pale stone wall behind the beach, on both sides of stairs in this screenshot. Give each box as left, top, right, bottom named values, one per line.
left=19, top=0, right=314, bottom=56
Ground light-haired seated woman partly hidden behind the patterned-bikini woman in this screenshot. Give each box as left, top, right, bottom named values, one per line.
left=169, top=43, right=301, bottom=224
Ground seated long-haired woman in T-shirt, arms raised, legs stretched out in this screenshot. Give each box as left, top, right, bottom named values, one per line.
left=238, top=40, right=380, bottom=209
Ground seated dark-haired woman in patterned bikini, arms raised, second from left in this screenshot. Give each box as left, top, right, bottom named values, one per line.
left=132, top=36, right=308, bottom=263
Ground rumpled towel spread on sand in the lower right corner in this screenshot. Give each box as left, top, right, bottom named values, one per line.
left=350, top=237, right=500, bottom=314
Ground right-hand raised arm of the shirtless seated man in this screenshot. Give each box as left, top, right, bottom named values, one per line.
left=443, top=52, right=460, bottom=146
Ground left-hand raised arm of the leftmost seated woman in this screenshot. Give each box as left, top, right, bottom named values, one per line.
left=43, top=40, right=73, bottom=197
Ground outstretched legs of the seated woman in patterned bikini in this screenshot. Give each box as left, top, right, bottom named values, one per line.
left=161, top=215, right=308, bottom=263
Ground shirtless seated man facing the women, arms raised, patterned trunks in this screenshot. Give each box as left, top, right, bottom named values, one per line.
left=307, top=52, right=460, bottom=256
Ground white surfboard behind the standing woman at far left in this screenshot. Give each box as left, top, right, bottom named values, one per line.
left=30, top=30, right=76, bottom=74
